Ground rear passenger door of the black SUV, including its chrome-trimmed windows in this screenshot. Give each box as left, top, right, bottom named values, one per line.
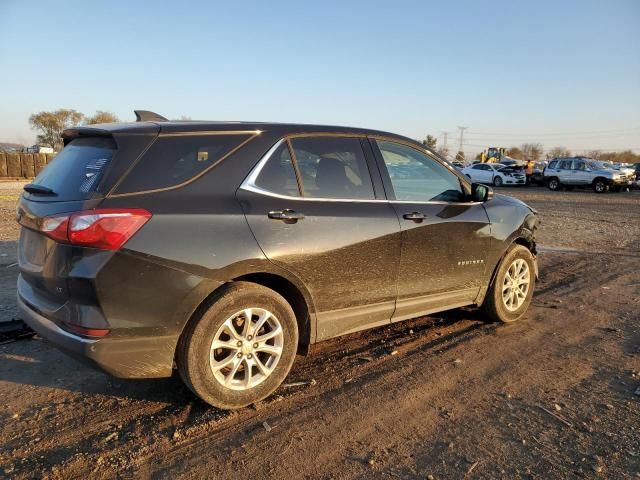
left=237, top=134, right=400, bottom=340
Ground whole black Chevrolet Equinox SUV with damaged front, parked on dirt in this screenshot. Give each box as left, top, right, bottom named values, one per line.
left=17, top=114, right=538, bottom=408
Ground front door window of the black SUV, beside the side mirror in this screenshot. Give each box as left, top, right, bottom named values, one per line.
left=377, top=141, right=462, bottom=202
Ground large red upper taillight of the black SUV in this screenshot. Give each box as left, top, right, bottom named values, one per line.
left=40, top=208, right=151, bottom=250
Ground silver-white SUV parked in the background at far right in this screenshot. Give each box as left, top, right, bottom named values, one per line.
left=544, top=157, right=632, bottom=193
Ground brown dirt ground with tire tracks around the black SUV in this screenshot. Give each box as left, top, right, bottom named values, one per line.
left=0, top=183, right=640, bottom=479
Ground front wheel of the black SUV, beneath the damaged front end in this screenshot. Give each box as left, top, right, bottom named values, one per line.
left=482, top=248, right=536, bottom=323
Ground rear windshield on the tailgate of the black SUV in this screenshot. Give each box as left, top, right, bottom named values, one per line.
left=29, top=137, right=117, bottom=201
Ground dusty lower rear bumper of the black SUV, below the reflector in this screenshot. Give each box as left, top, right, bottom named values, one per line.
left=18, top=295, right=178, bottom=378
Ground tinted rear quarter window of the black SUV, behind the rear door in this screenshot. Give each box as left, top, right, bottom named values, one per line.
left=117, top=135, right=249, bottom=193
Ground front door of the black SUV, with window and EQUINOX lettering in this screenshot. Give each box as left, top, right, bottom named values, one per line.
left=372, top=139, right=491, bottom=321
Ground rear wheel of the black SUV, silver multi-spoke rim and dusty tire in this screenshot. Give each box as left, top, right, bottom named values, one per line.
left=176, top=282, right=298, bottom=409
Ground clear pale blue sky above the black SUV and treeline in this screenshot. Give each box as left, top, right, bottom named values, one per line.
left=0, top=0, right=640, bottom=154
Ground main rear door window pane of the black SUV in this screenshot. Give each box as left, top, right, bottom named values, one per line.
left=291, top=137, right=374, bottom=200
